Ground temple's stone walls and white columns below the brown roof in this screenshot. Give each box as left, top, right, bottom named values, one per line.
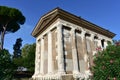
left=34, top=19, right=112, bottom=80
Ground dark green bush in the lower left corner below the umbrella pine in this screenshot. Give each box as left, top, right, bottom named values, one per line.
left=0, top=49, right=16, bottom=80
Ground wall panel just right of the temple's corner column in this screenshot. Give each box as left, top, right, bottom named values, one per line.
left=63, top=27, right=73, bottom=74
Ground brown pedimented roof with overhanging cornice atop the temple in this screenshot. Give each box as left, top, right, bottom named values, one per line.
left=32, top=7, right=116, bottom=38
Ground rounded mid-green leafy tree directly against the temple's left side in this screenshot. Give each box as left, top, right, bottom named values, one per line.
left=22, top=43, right=36, bottom=72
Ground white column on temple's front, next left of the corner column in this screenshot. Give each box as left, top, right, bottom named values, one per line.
left=48, top=32, right=53, bottom=74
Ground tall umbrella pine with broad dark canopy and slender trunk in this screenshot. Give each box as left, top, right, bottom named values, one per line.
left=0, top=6, right=25, bottom=49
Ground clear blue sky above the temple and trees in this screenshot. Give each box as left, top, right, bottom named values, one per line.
left=0, top=0, right=120, bottom=53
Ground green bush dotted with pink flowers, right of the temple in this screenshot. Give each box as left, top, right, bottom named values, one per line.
left=92, top=44, right=120, bottom=80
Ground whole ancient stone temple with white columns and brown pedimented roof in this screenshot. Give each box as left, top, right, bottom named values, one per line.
left=32, top=8, right=115, bottom=80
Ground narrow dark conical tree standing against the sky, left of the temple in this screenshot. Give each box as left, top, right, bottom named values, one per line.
left=13, top=38, right=22, bottom=58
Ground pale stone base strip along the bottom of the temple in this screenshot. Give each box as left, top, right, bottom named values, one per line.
left=32, top=73, right=89, bottom=80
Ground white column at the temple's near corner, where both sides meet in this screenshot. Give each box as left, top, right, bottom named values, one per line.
left=57, top=24, right=65, bottom=74
